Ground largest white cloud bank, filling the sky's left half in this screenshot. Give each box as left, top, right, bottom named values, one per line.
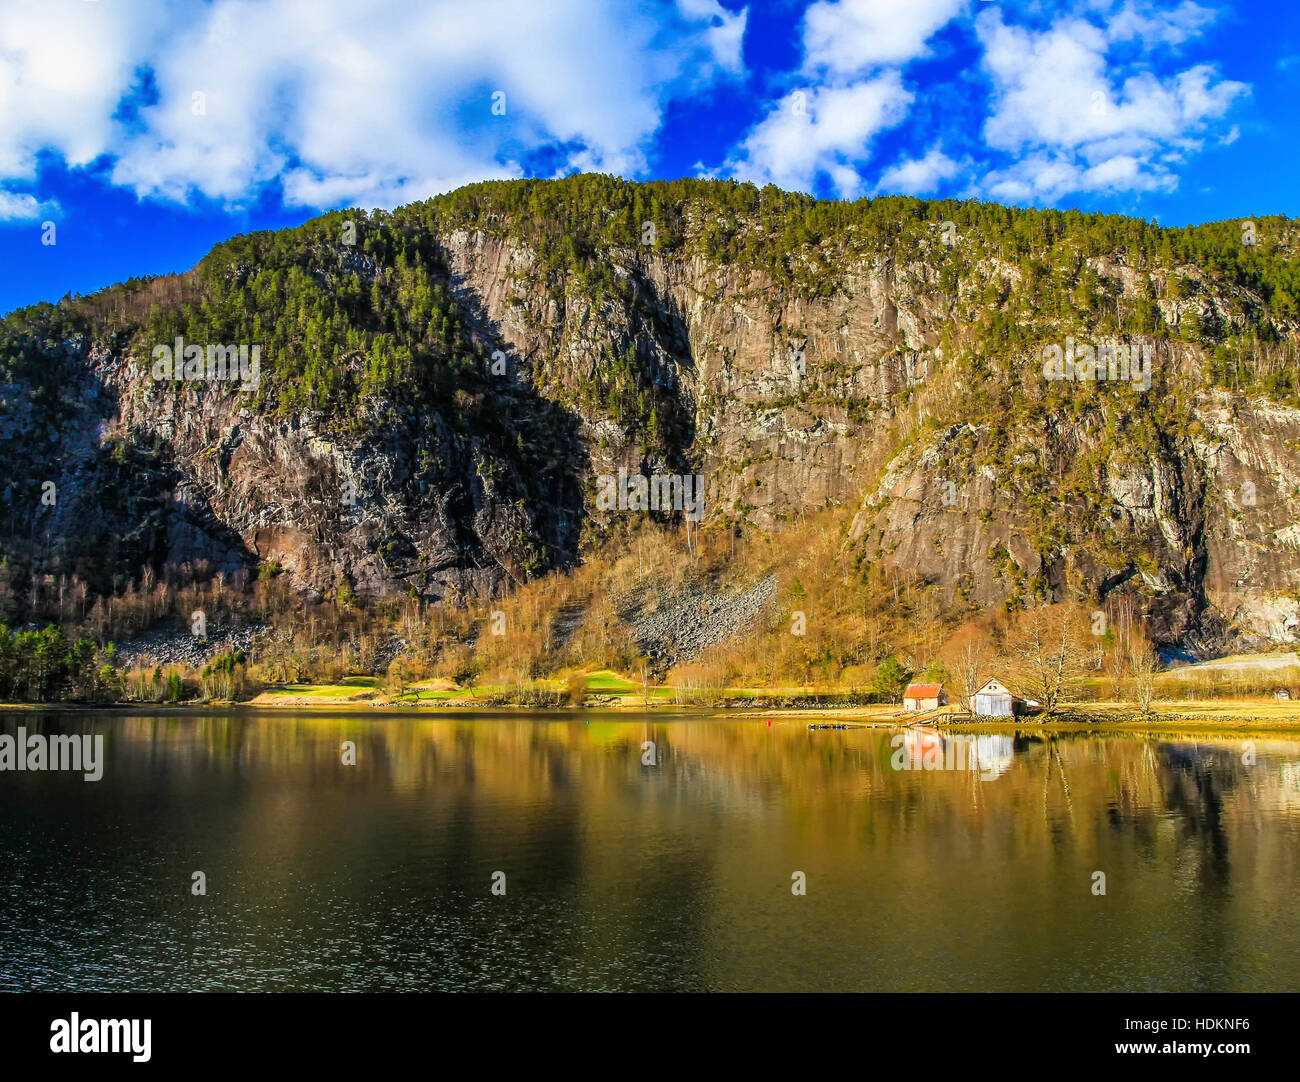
left=0, top=0, right=746, bottom=207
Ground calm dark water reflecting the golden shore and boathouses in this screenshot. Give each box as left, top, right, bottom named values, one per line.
left=0, top=711, right=1300, bottom=991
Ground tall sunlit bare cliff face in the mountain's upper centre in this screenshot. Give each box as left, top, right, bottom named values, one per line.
left=445, top=233, right=944, bottom=528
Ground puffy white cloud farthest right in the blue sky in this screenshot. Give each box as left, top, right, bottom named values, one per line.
left=976, top=4, right=1249, bottom=200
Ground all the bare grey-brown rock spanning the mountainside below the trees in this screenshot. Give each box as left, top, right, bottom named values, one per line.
left=0, top=179, right=1300, bottom=645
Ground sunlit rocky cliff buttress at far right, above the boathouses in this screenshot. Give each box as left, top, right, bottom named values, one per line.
left=850, top=393, right=1300, bottom=652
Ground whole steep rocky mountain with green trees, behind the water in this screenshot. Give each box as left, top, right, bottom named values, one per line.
left=0, top=176, right=1300, bottom=692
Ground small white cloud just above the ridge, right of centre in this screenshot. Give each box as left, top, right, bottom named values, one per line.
left=728, top=72, right=913, bottom=198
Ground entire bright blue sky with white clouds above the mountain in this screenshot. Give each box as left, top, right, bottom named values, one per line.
left=0, top=0, right=1300, bottom=312
